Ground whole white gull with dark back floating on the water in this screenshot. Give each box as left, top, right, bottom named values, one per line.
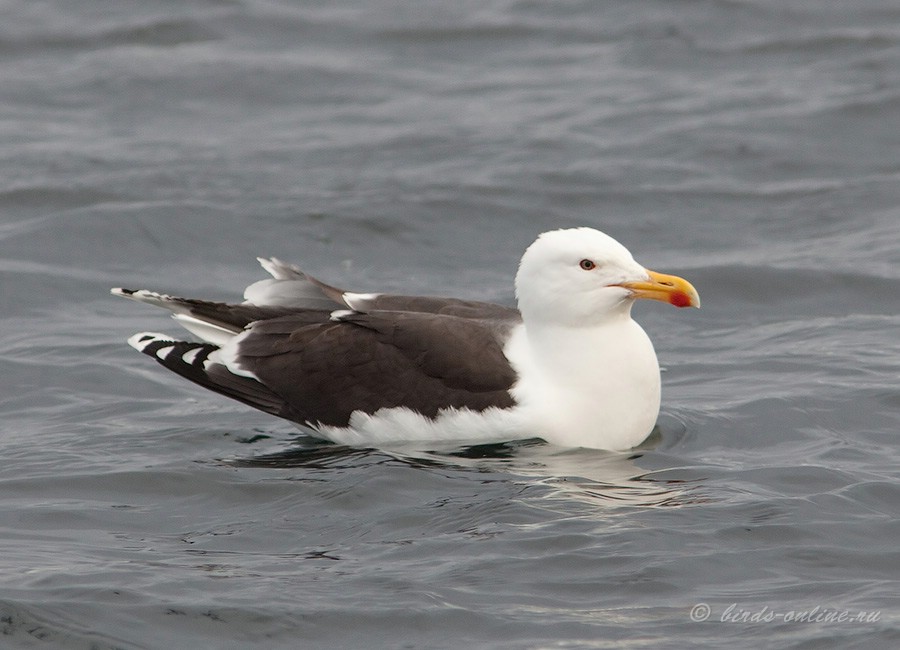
left=112, top=228, right=700, bottom=451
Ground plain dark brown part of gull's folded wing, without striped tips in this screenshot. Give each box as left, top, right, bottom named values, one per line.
left=236, top=312, right=516, bottom=426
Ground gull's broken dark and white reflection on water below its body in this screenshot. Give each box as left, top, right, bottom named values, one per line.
left=229, top=433, right=706, bottom=507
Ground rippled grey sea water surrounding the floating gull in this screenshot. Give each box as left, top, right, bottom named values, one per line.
left=0, top=0, right=900, bottom=649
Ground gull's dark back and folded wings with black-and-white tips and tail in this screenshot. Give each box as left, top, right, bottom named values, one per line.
left=112, top=258, right=521, bottom=426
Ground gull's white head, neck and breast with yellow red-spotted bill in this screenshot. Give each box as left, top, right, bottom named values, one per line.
left=508, top=228, right=700, bottom=450
